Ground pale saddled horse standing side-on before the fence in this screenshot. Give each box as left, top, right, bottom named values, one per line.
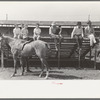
left=0, top=33, right=50, bottom=79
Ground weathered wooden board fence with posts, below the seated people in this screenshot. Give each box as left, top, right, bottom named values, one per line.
left=1, top=37, right=96, bottom=68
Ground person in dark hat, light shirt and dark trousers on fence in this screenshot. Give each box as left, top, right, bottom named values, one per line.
left=71, top=22, right=83, bottom=49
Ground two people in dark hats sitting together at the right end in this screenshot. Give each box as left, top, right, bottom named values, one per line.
left=71, top=20, right=96, bottom=49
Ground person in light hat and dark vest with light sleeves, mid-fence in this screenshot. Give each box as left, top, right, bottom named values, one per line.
left=49, top=22, right=62, bottom=51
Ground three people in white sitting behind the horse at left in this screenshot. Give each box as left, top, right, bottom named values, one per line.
left=13, top=23, right=41, bottom=41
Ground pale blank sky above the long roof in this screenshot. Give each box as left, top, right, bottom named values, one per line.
left=0, top=1, right=100, bottom=21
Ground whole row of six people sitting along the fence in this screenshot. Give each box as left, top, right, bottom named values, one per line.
left=13, top=20, right=96, bottom=51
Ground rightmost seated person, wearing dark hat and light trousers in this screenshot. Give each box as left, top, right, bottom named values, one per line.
left=85, top=20, right=96, bottom=47
